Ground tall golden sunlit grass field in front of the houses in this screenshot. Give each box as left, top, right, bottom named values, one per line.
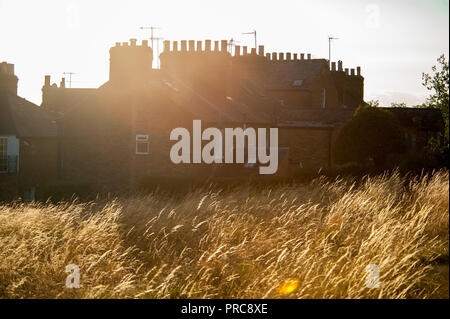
left=0, top=171, right=449, bottom=298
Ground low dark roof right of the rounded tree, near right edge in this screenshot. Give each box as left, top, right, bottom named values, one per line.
left=386, top=107, right=444, bottom=131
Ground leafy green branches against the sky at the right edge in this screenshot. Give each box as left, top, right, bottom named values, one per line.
left=422, top=55, right=449, bottom=142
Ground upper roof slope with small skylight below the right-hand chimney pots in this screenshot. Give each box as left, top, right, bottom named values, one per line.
left=266, top=59, right=327, bottom=90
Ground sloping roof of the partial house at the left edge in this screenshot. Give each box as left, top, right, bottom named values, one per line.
left=0, top=91, right=57, bottom=137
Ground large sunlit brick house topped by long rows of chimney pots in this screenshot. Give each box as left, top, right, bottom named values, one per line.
left=35, top=39, right=442, bottom=191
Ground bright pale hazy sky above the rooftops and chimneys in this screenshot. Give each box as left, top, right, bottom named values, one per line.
left=0, top=0, right=449, bottom=106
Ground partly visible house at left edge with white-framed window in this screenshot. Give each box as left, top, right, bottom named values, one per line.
left=0, top=62, right=57, bottom=200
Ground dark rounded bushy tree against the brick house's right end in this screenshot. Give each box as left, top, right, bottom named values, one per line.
left=335, top=105, right=404, bottom=166
